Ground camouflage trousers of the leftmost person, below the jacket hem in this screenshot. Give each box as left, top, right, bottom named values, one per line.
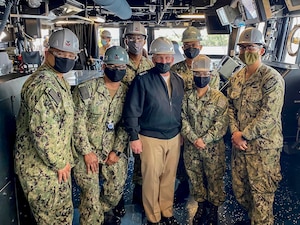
left=19, top=170, right=73, bottom=225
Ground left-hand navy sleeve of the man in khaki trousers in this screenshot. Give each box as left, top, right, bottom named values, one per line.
left=123, top=75, right=147, bottom=141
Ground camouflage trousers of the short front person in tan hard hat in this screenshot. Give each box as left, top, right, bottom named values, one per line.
left=183, top=141, right=225, bottom=206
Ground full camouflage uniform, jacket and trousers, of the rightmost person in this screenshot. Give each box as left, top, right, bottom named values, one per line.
left=228, top=64, right=284, bottom=225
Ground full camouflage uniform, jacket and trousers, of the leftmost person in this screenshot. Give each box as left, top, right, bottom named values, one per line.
left=15, top=64, right=76, bottom=225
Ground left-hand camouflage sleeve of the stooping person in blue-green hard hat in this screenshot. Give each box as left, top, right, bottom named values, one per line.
left=73, top=86, right=92, bottom=155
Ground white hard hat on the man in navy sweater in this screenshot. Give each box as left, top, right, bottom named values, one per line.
left=150, top=37, right=175, bottom=55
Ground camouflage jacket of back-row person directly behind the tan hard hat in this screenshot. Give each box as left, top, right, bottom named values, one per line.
left=171, top=60, right=220, bottom=92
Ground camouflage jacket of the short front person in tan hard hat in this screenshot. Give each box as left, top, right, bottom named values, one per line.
left=181, top=88, right=228, bottom=147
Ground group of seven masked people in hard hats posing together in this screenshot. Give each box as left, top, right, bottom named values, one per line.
left=15, top=22, right=284, bottom=225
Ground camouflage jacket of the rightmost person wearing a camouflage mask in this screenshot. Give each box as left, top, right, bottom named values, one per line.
left=227, top=64, right=285, bottom=149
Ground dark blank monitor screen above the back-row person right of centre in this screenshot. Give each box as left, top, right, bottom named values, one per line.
left=205, top=14, right=231, bottom=34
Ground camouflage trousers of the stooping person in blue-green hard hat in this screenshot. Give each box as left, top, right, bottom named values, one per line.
left=74, top=153, right=127, bottom=225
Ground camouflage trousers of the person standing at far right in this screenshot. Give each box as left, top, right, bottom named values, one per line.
left=231, top=145, right=282, bottom=225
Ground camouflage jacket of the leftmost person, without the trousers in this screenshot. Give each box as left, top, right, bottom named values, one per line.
left=15, top=64, right=75, bottom=176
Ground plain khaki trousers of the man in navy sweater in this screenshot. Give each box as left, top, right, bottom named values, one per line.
left=140, top=134, right=180, bottom=223
